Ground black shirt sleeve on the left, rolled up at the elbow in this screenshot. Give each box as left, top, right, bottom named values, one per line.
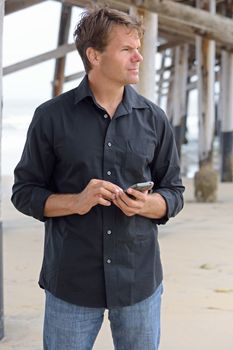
left=11, top=109, right=55, bottom=221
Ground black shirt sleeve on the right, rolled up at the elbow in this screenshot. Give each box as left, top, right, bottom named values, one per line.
left=151, top=110, right=185, bottom=224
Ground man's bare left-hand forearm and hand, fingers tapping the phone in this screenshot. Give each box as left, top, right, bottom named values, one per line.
left=44, top=179, right=122, bottom=217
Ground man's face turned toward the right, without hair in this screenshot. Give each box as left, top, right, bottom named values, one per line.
left=95, top=25, right=143, bottom=86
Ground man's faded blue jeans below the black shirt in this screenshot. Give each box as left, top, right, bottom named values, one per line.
left=44, top=285, right=163, bottom=350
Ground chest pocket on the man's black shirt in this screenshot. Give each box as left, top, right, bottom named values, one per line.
left=124, top=139, right=154, bottom=184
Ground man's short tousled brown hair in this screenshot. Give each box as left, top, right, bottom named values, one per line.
left=74, top=6, right=144, bottom=73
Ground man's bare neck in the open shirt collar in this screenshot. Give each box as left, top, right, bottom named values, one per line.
left=88, top=74, right=124, bottom=118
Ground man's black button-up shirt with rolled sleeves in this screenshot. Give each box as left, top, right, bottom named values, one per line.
left=12, top=77, right=184, bottom=307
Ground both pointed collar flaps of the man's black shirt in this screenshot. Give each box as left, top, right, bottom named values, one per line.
left=75, top=75, right=149, bottom=116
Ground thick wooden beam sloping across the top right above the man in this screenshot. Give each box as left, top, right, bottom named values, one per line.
left=55, top=0, right=233, bottom=49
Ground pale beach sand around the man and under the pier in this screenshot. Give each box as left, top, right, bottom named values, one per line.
left=0, top=177, right=233, bottom=350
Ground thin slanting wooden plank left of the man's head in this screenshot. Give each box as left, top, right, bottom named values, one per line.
left=3, top=44, right=76, bottom=75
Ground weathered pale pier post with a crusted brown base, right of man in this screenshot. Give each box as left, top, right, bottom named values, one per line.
left=194, top=0, right=217, bottom=202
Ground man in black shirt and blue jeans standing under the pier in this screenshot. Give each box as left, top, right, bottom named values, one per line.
left=12, top=8, right=184, bottom=350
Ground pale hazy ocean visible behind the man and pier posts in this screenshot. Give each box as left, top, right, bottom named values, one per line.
left=1, top=99, right=198, bottom=178
